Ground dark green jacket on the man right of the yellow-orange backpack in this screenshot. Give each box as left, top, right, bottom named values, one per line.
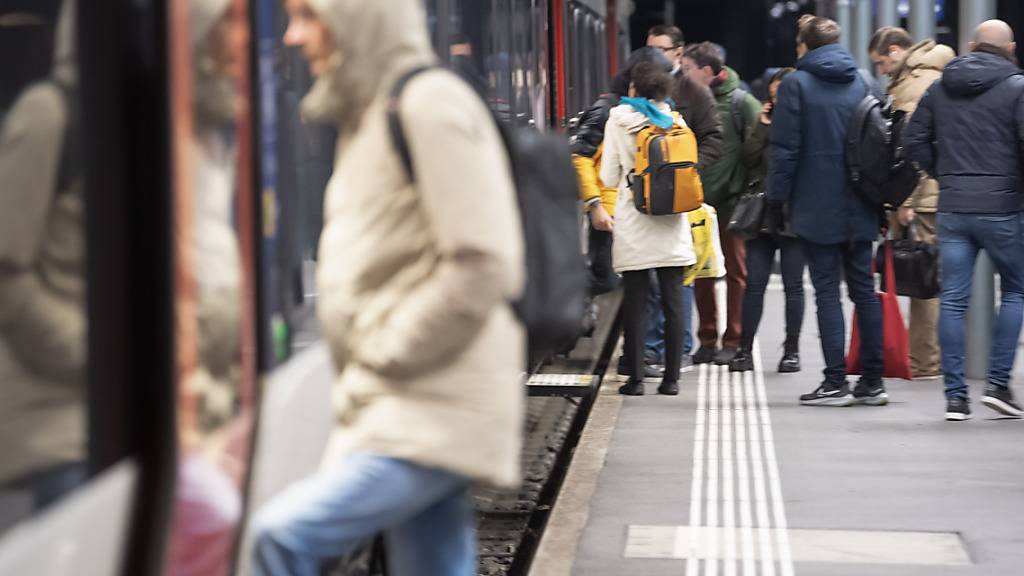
left=700, top=67, right=761, bottom=221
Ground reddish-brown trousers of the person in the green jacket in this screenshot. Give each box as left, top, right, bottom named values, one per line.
left=694, top=223, right=746, bottom=348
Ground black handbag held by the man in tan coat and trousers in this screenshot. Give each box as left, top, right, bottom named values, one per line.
left=874, top=223, right=942, bottom=300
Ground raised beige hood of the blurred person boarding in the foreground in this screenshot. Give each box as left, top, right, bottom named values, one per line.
left=302, top=0, right=436, bottom=131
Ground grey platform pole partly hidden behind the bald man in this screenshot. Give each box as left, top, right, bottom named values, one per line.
left=959, top=0, right=995, bottom=380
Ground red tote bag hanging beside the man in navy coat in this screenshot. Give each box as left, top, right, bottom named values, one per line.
left=846, top=240, right=913, bottom=380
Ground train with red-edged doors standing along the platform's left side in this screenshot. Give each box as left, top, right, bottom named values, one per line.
left=0, top=0, right=629, bottom=576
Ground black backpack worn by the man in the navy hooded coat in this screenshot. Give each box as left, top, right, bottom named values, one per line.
left=846, top=94, right=921, bottom=208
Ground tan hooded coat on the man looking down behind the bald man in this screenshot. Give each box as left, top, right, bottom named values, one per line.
left=889, top=40, right=956, bottom=212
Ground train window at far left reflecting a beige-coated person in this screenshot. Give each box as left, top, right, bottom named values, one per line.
left=0, top=0, right=88, bottom=532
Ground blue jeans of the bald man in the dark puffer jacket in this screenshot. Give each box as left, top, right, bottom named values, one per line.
left=937, top=212, right=1024, bottom=398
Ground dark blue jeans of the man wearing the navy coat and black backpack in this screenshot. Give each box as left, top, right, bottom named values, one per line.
left=804, top=241, right=885, bottom=384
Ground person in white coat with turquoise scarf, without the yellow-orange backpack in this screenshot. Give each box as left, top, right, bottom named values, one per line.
left=601, top=64, right=696, bottom=396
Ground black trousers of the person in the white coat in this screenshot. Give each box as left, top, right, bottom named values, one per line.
left=623, top=266, right=683, bottom=382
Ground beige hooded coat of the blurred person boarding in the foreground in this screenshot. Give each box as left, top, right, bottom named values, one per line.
left=303, top=0, right=524, bottom=486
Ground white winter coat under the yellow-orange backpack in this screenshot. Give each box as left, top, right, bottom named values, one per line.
left=601, top=102, right=696, bottom=273
